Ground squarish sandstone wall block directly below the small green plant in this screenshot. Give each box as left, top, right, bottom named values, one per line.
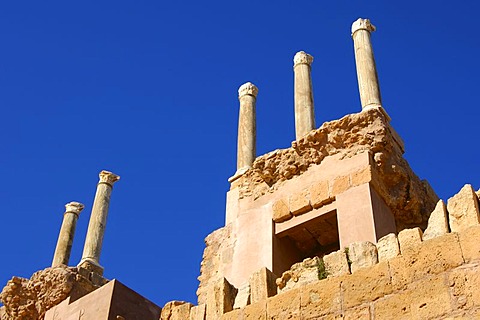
left=300, top=278, right=342, bottom=319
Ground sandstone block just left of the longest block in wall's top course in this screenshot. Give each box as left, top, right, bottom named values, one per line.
left=339, top=262, right=393, bottom=308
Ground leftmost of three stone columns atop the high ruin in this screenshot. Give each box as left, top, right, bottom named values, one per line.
left=237, top=82, right=258, bottom=174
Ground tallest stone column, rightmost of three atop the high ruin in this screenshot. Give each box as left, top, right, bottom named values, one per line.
left=352, top=18, right=382, bottom=110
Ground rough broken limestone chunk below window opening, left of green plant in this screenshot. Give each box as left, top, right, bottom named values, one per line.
left=276, top=257, right=325, bottom=292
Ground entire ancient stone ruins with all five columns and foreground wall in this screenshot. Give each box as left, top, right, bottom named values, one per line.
left=0, top=19, right=480, bottom=320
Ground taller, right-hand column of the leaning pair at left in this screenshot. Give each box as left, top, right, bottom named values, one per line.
left=78, top=170, right=120, bottom=275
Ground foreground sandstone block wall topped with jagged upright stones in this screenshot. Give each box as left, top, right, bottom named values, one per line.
left=162, top=185, right=480, bottom=320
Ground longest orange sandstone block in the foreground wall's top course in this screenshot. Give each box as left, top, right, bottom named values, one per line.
left=388, top=233, right=464, bottom=289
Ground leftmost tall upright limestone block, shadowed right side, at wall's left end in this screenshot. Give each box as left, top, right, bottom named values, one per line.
left=207, top=278, right=237, bottom=319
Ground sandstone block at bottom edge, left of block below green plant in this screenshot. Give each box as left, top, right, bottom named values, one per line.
left=267, top=288, right=301, bottom=320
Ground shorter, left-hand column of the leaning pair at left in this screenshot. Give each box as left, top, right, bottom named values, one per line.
left=52, top=202, right=84, bottom=267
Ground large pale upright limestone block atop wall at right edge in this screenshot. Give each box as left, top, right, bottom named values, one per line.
left=447, top=184, right=480, bottom=232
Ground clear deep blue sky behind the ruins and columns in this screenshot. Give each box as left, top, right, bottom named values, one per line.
left=0, top=0, right=480, bottom=306
